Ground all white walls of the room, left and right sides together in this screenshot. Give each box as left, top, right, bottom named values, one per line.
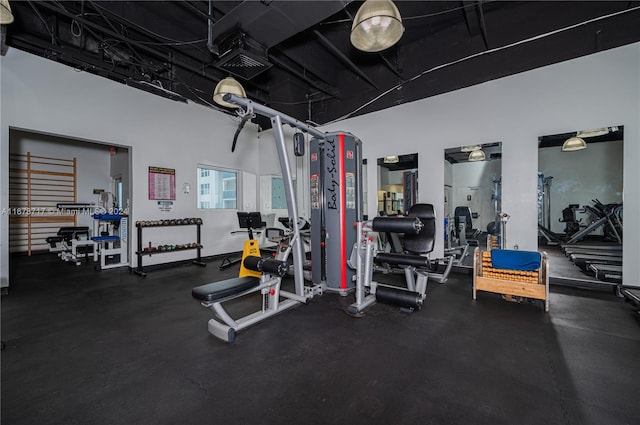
left=0, top=43, right=640, bottom=286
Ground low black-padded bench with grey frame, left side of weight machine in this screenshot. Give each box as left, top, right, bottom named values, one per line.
left=191, top=256, right=306, bottom=343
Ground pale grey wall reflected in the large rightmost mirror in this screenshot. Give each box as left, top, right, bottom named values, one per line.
left=538, top=139, right=633, bottom=234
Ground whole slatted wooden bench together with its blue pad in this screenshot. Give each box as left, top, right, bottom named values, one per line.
left=473, top=248, right=549, bottom=312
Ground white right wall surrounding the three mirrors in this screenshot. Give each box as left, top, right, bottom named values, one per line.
left=327, top=43, right=640, bottom=286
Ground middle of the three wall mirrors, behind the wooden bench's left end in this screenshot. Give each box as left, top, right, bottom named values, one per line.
left=444, top=142, right=502, bottom=266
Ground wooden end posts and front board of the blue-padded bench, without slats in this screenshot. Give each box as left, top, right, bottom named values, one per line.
left=473, top=248, right=549, bottom=312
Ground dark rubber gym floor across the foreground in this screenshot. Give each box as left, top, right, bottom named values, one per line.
left=1, top=255, right=640, bottom=425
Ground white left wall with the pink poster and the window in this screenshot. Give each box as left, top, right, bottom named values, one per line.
left=0, top=48, right=262, bottom=286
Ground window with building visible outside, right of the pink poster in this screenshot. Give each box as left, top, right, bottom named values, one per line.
left=198, top=165, right=238, bottom=209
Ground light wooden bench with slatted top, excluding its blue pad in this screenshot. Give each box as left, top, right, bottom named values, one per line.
left=473, top=248, right=549, bottom=311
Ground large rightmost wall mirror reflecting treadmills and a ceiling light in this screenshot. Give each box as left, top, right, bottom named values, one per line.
left=537, top=126, right=624, bottom=283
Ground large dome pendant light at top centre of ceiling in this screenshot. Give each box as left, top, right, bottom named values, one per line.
left=351, top=0, right=404, bottom=52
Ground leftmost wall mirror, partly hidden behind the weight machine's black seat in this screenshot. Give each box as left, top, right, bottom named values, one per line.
left=377, top=153, right=418, bottom=215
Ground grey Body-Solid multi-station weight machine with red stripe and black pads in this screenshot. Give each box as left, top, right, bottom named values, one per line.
left=192, top=94, right=451, bottom=342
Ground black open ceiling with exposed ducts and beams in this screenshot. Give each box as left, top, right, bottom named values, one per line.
left=6, top=0, right=640, bottom=127
